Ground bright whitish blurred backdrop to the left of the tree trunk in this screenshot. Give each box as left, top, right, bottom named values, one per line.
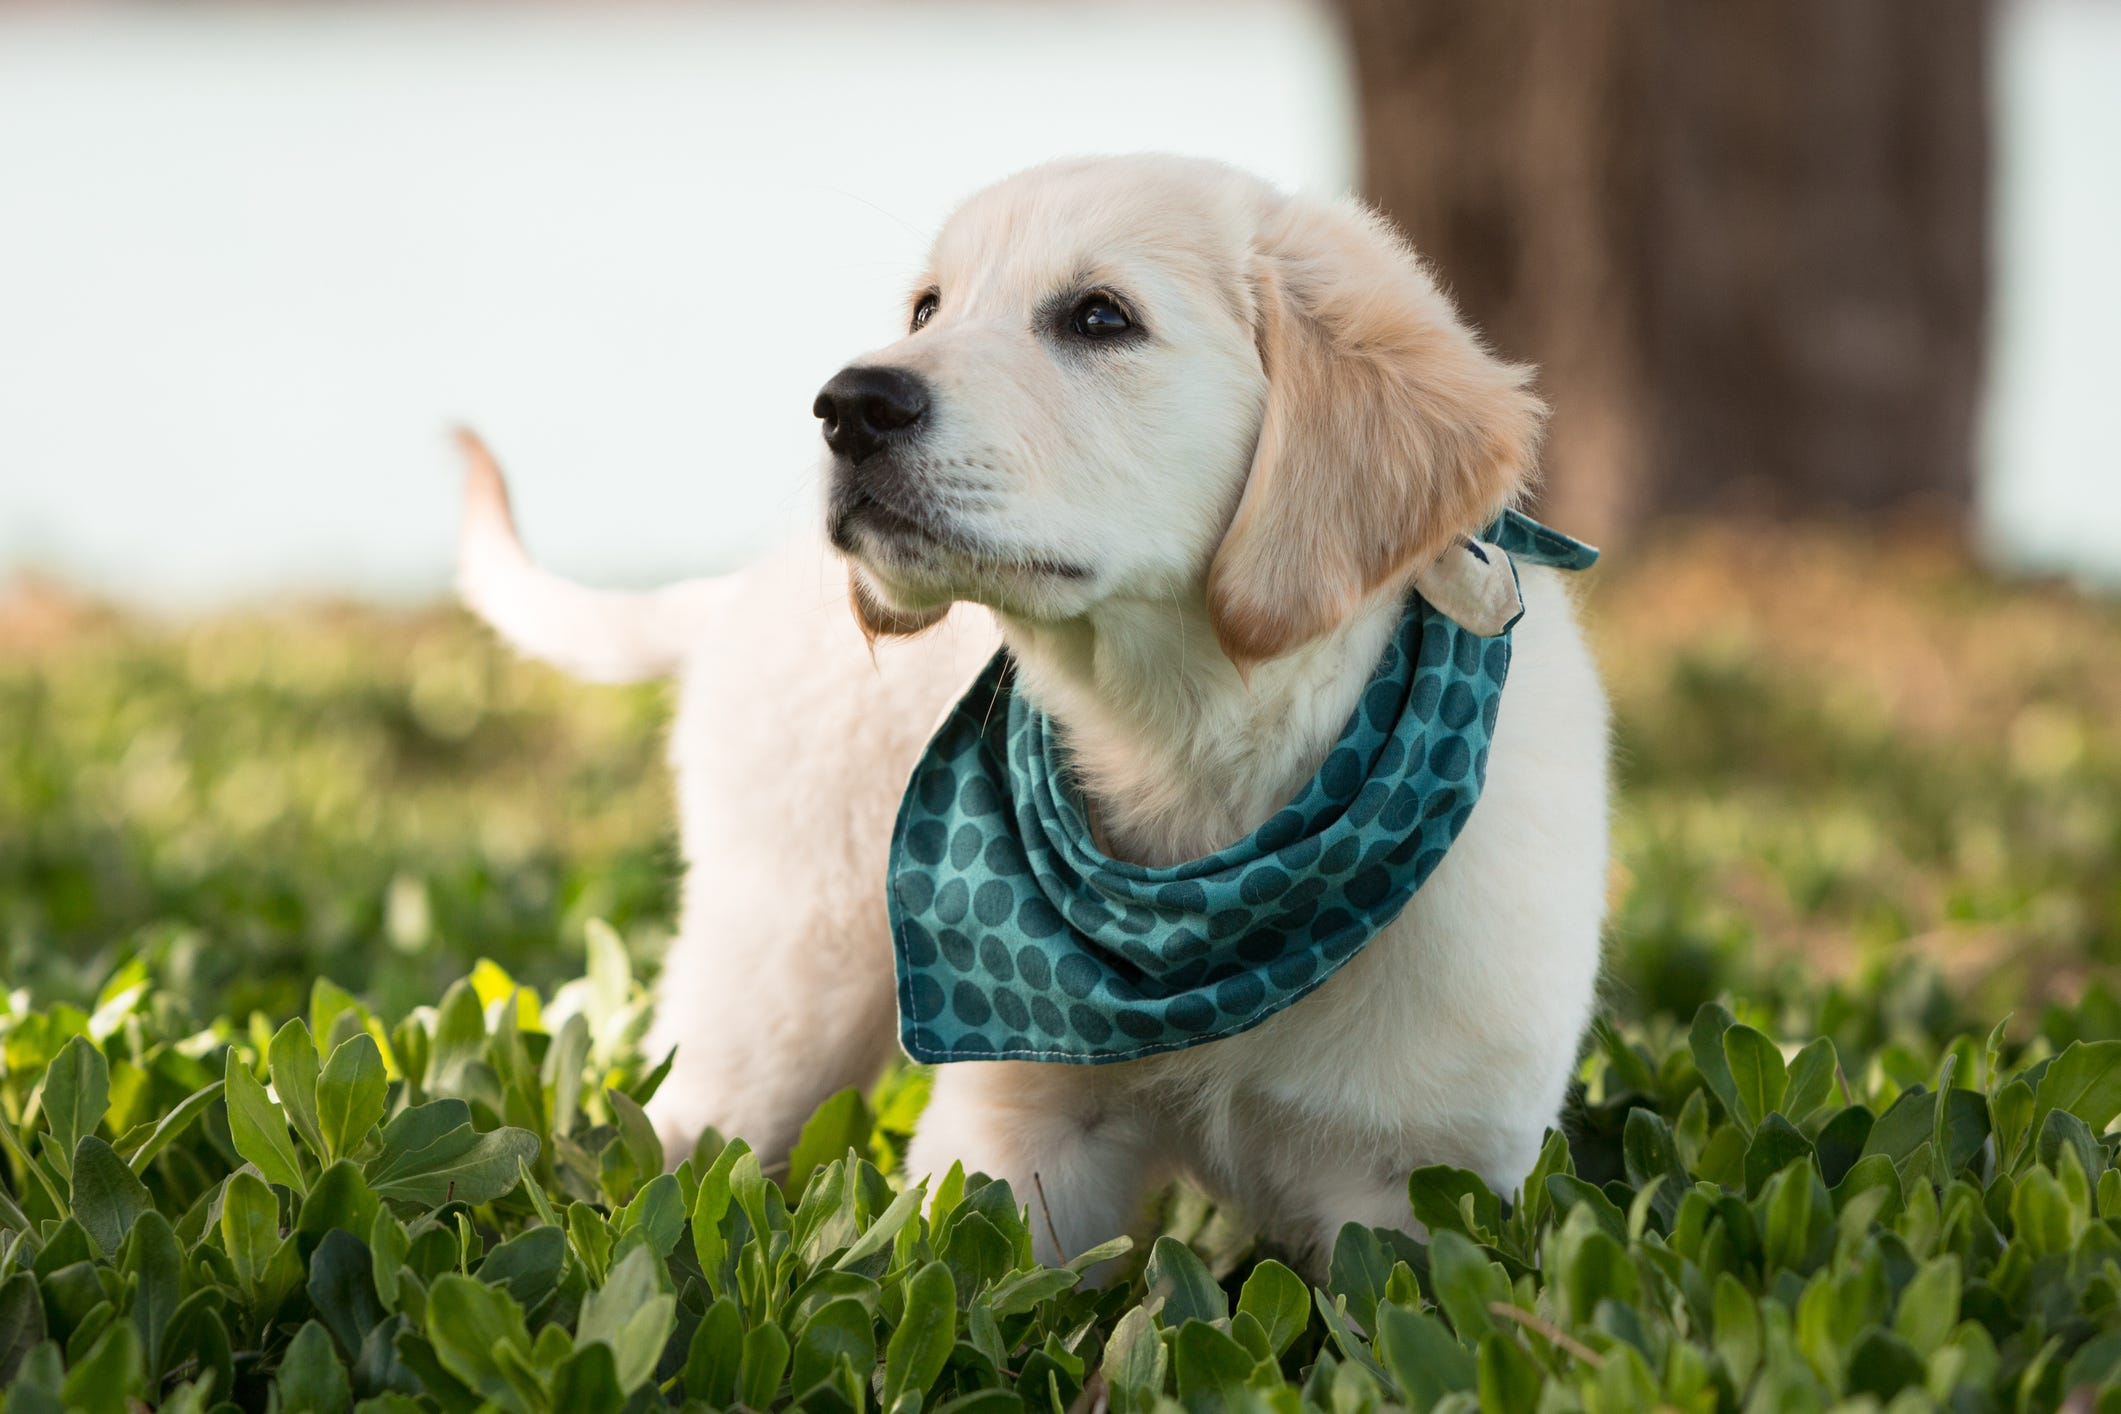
left=0, top=0, right=1355, bottom=604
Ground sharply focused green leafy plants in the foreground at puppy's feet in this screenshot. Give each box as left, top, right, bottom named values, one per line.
left=0, top=945, right=2121, bottom=1414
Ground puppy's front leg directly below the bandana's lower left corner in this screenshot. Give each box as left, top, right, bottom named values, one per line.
left=906, top=1062, right=1164, bottom=1278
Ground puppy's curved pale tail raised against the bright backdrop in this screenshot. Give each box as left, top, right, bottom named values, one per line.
left=456, top=428, right=730, bottom=683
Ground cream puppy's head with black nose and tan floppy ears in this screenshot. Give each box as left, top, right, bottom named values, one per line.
left=817, top=157, right=1542, bottom=664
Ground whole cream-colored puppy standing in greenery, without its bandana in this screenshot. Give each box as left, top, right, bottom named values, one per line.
left=462, top=157, right=1606, bottom=1259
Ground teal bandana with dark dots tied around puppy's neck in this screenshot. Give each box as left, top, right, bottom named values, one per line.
left=889, top=511, right=1597, bottom=1064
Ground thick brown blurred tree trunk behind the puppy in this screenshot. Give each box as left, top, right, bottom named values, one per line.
left=1338, top=0, right=1987, bottom=534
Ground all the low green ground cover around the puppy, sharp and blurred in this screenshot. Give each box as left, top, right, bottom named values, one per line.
left=0, top=532, right=2121, bottom=1414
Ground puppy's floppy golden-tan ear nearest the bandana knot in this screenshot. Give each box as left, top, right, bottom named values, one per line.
left=1207, top=201, right=1546, bottom=666
